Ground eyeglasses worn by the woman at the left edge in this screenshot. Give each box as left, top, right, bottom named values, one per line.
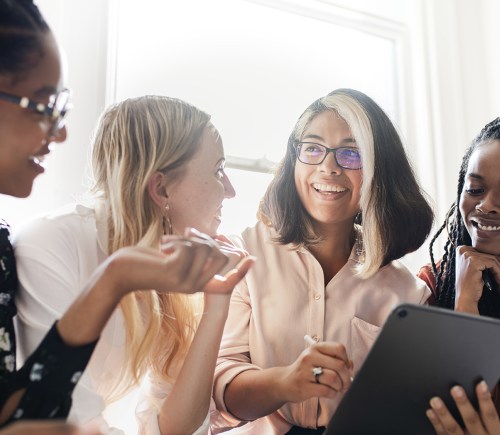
left=0, top=89, right=71, bottom=136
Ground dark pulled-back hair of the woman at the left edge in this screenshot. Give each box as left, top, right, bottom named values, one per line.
left=0, top=0, right=50, bottom=83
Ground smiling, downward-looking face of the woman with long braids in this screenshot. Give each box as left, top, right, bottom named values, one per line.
left=460, top=140, right=500, bottom=255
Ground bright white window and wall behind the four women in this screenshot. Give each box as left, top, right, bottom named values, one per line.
left=0, top=0, right=500, bottom=434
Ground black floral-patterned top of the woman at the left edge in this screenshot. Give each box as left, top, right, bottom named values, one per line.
left=0, top=219, right=97, bottom=427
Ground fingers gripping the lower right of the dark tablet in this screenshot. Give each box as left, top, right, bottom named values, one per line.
left=427, top=381, right=500, bottom=435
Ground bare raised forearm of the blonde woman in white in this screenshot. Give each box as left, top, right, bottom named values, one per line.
left=158, top=295, right=229, bottom=435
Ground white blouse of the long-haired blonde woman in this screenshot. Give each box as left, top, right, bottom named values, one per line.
left=14, top=205, right=208, bottom=435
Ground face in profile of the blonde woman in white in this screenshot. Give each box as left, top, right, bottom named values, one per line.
left=167, top=124, right=235, bottom=236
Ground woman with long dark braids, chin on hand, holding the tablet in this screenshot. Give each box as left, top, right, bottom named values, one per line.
left=419, top=118, right=500, bottom=434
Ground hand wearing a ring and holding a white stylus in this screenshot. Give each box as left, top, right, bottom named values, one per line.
left=279, top=341, right=353, bottom=403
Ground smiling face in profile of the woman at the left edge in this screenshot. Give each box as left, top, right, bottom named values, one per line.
left=0, top=32, right=66, bottom=198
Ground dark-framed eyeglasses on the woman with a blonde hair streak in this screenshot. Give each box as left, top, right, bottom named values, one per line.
left=295, top=142, right=363, bottom=170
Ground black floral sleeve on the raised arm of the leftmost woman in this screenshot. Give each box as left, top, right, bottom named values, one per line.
left=1, top=324, right=97, bottom=423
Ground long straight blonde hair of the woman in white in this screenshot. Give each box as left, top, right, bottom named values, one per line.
left=92, top=96, right=210, bottom=400
